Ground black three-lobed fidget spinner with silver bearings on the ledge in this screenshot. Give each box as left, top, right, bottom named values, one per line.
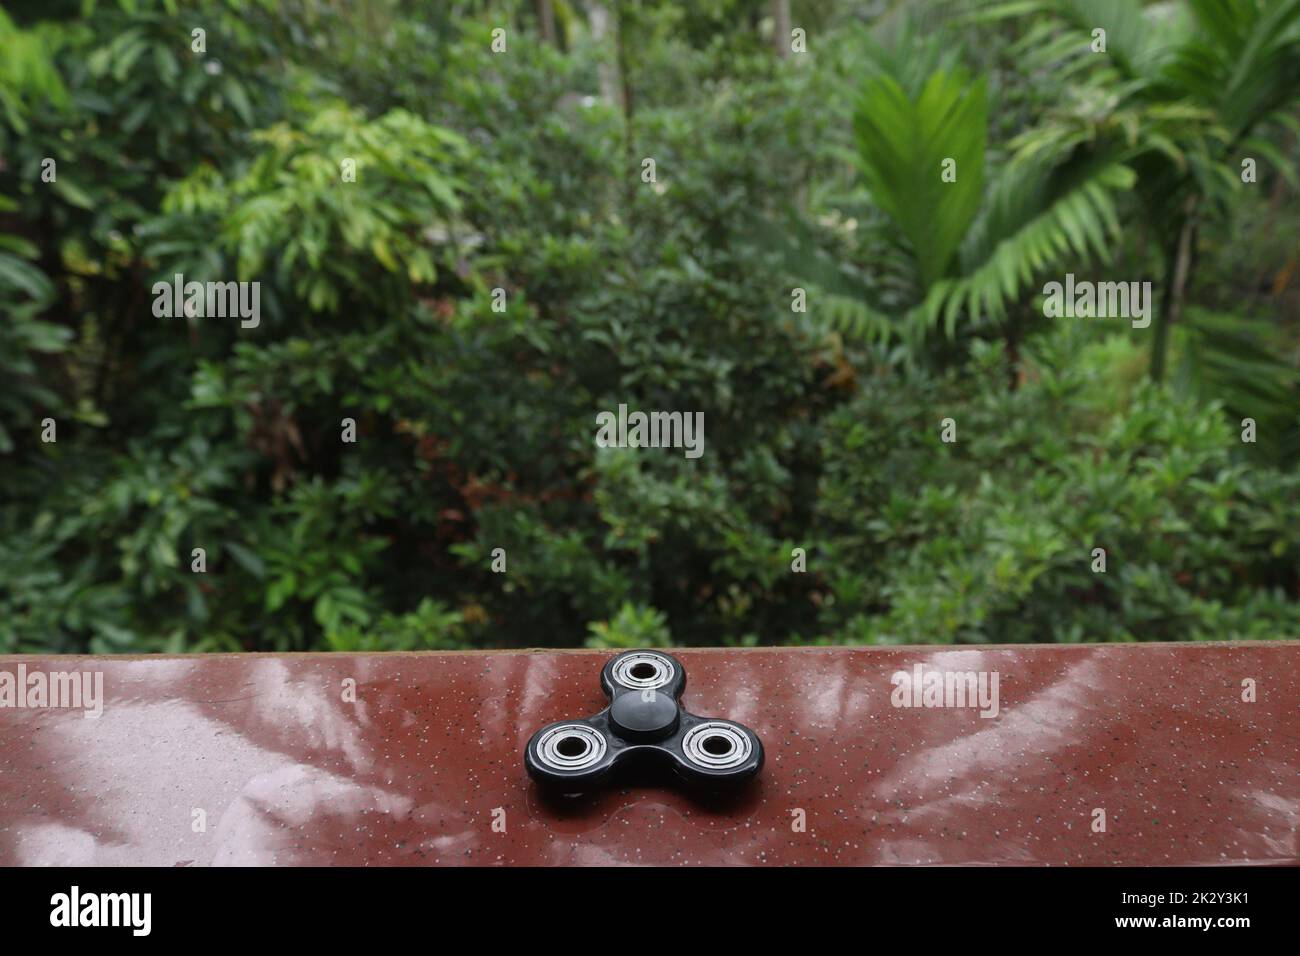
left=524, top=650, right=763, bottom=793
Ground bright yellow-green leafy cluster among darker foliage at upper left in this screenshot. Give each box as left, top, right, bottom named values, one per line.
left=156, top=107, right=464, bottom=312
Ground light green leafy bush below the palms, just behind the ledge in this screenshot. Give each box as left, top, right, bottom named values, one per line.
left=816, top=329, right=1300, bottom=644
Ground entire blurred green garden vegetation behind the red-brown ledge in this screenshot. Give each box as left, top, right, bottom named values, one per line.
left=0, top=0, right=1300, bottom=653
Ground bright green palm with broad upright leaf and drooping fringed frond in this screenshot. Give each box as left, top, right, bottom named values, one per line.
left=850, top=26, right=1135, bottom=347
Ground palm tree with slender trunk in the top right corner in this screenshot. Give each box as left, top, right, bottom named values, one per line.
left=971, top=0, right=1300, bottom=388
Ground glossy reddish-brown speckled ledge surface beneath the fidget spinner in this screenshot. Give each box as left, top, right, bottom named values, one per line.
left=0, top=643, right=1300, bottom=866
